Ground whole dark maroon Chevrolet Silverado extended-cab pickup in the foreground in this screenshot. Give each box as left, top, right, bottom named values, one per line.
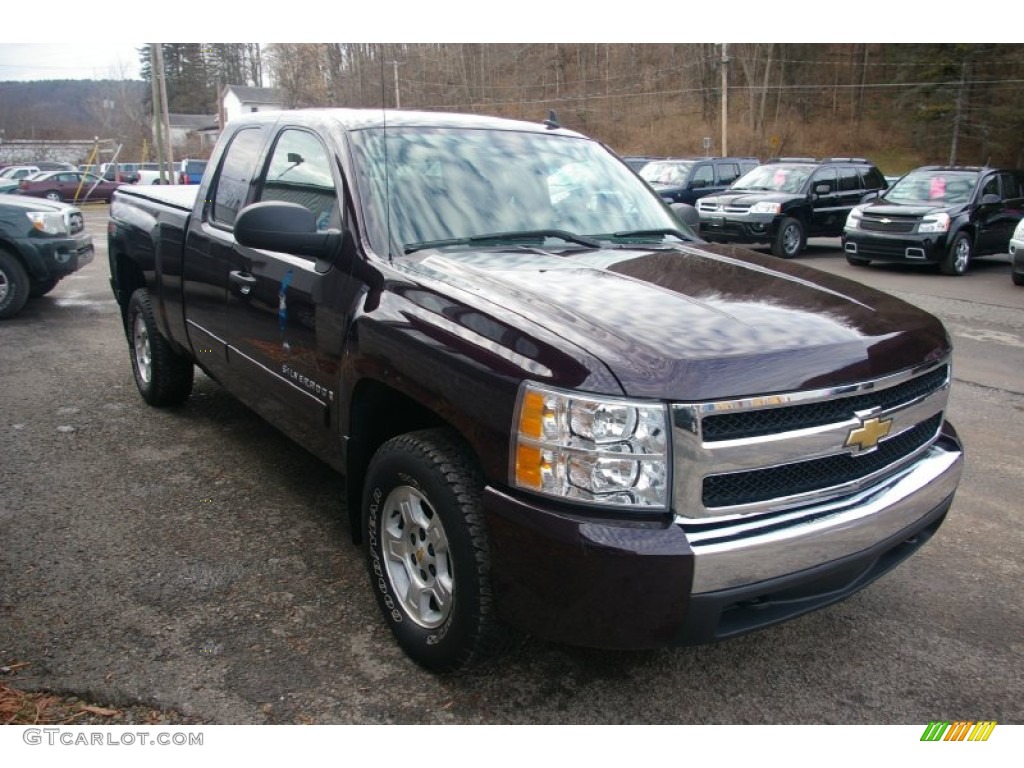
left=109, top=110, right=963, bottom=672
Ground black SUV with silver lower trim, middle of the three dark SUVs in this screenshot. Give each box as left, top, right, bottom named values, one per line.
left=697, top=158, right=888, bottom=258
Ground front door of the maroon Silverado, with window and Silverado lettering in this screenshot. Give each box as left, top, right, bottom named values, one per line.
left=226, top=126, right=352, bottom=454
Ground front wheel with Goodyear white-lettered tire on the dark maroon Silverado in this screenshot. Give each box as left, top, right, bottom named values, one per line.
left=362, top=429, right=509, bottom=672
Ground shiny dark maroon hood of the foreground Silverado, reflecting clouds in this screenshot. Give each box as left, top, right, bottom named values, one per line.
left=403, top=244, right=950, bottom=401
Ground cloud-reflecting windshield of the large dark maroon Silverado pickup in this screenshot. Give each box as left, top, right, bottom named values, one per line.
left=351, top=128, right=687, bottom=253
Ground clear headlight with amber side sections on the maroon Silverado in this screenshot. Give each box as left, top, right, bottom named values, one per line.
left=511, top=382, right=670, bottom=509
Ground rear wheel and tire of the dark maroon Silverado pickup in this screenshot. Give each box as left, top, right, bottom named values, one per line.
left=127, top=288, right=195, bottom=408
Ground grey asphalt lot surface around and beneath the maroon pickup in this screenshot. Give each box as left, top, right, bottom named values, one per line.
left=0, top=214, right=1024, bottom=727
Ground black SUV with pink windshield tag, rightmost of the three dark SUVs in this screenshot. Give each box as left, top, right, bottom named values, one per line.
left=843, top=166, right=1024, bottom=275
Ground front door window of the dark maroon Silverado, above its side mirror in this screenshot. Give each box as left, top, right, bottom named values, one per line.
left=259, top=128, right=341, bottom=230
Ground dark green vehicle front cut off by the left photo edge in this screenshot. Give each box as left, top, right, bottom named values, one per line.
left=0, top=195, right=94, bottom=319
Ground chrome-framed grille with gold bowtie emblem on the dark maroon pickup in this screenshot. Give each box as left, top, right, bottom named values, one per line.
left=672, top=360, right=950, bottom=519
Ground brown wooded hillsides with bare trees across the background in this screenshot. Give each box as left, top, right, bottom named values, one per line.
left=0, top=43, right=1024, bottom=173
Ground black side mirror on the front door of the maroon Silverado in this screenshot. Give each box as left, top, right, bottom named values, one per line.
left=234, top=201, right=341, bottom=264
